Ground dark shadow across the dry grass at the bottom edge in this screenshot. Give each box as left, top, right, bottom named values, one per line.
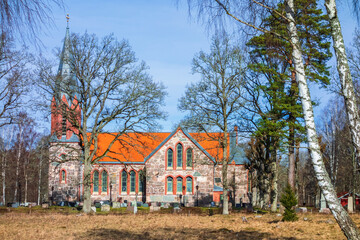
left=76, top=228, right=296, bottom=240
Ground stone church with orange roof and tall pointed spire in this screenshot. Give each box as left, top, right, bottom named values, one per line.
left=49, top=27, right=248, bottom=206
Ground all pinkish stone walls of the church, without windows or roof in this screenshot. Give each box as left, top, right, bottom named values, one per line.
left=49, top=130, right=248, bottom=206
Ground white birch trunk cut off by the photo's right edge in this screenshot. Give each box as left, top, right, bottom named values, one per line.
left=325, top=0, right=360, bottom=171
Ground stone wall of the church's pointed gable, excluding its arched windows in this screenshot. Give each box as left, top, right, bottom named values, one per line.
left=146, top=131, right=214, bottom=206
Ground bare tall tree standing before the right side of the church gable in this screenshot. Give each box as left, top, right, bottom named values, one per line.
left=179, top=36, right=244, bottom=214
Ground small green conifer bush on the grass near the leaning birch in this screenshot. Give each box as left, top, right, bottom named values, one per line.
left=280, top=184, right=298, bottom=222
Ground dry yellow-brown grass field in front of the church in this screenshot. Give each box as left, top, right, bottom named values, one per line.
left=0, top=212, right=360, bottom=240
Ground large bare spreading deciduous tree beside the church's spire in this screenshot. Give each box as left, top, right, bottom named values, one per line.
left=40, top=29, right=165, bottom=213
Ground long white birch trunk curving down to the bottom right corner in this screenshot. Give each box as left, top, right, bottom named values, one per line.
left=286, top=0, right=360, bottom=239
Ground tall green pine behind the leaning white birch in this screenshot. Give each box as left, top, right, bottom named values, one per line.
left=247, top=0, right=331, bottom=211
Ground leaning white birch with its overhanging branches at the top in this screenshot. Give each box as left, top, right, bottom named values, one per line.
left=186, top=0, right=360, bottom=236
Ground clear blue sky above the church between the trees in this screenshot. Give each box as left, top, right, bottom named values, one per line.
left=36, top=0, right=356, bottom=131
